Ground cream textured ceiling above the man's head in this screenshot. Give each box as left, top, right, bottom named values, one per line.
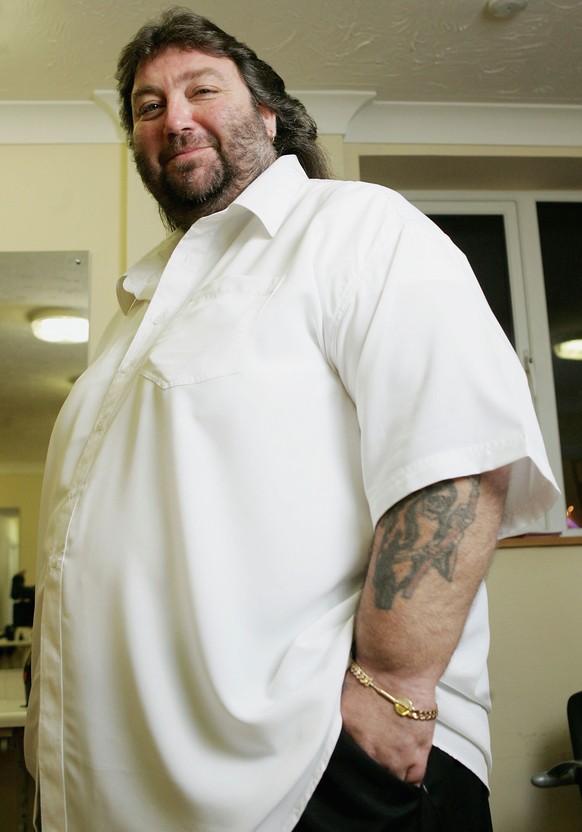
left=0, top=0, right=582, bottom=104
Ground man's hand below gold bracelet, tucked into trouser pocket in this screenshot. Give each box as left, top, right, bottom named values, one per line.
left=341, top=669, right=435, bottom=786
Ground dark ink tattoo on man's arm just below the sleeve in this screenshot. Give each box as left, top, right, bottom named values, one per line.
left=373, top=476, right=480, bottom=610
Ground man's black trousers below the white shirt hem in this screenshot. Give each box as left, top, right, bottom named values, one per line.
left=295, top=731, right=493, bottom=832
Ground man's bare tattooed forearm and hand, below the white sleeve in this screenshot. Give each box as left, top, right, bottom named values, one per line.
left=342, top=468, right=509, bottom=785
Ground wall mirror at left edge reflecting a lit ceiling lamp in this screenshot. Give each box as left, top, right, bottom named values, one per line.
left=0, top=251, right=89, bottom=629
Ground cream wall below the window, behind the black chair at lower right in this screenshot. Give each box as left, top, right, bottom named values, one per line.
left=487, top=545, right=582, bottom=832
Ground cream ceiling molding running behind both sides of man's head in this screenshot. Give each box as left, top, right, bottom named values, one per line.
left=0, top=90, right=582, bottom=148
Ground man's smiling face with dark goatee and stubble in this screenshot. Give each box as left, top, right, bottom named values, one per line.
left=132, top=47, right=276, bottom=229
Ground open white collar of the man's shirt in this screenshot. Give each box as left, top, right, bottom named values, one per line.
left=117, top=156, right=307, bottom=315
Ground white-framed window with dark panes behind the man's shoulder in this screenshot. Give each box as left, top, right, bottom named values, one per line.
left=405, top=192, right=582, bottom=534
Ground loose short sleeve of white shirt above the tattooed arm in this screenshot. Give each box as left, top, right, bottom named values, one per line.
left=336, top=209, right=558, bottom=536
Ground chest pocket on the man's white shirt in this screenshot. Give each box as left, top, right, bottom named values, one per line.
left=140, top=274, right=283, bottom=389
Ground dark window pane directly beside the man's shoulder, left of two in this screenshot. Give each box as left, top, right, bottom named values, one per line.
left=429, top=214, right=515, bottom=347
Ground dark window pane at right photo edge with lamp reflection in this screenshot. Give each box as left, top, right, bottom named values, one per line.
left=537, top=202, right=582, bottom=527
